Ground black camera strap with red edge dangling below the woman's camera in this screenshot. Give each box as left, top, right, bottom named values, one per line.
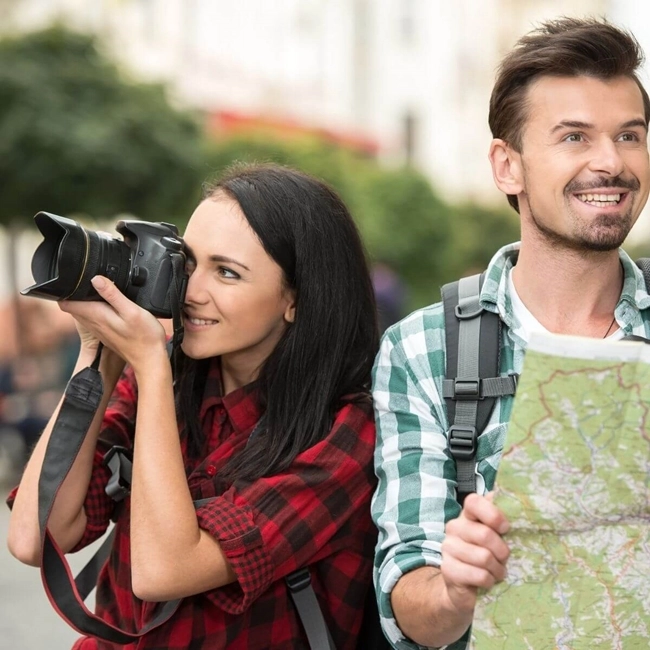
left=38, top=344, right=180, bottom=645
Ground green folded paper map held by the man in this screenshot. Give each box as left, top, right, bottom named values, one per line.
left=471, top=334, right=650, bottom=650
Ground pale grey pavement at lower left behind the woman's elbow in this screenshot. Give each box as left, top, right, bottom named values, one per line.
left=0, top=468, right=98, bottom=650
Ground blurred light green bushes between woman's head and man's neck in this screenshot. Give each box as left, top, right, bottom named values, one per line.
left=200, top=134, right=519, bottom=309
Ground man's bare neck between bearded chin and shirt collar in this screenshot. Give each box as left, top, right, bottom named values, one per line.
left=512, top=241, right=623, bottom=338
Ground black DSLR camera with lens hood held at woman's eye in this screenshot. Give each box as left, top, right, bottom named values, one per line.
left=20, top=212, right=187, bottom=318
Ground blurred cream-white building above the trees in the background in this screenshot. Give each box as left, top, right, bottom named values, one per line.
left=0, top=0, right=650, bottom=213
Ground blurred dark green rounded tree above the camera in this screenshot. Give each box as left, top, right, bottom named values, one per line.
left=0, top=26, right=202, bottom=223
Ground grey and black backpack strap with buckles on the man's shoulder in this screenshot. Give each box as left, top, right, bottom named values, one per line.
left=442, top=274, right=517, bottom=504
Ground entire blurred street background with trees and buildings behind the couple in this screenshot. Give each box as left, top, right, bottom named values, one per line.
left=0, top=0, right=650, bottom=650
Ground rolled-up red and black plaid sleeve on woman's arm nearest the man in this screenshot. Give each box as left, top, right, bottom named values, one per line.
left=192, top=399, right=375, bottom=614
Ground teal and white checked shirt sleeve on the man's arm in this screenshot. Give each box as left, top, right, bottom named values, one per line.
left=372, top=304, right=466, bottom=650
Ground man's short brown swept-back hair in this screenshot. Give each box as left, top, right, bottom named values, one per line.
left=489, top=18, right=650, bottom=212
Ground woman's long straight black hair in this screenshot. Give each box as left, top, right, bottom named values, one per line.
left=177, top=164, right=379, bottom=481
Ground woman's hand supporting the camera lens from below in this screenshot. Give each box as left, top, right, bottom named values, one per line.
left=59, top=276, right=167, bottom=374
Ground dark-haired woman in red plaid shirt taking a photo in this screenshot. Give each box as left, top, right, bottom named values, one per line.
left=9, top=165, right=378, bottom=650
